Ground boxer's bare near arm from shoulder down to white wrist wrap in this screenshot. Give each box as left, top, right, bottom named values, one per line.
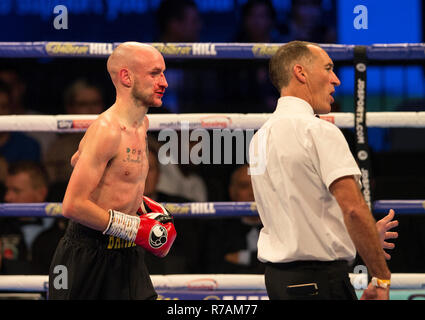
left=62, top=120, right=121, bottom=231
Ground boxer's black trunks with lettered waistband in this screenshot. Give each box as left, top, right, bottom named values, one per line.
left=48, top=221, right=157, bottom=300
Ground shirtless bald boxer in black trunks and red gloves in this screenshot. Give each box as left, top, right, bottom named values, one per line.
left=49, top=42, right=176, bottom=299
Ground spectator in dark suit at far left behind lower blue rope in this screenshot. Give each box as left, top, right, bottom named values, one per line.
left=2, top=161, right=67, bottom=274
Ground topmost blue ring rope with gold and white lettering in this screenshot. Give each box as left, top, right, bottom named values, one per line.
left=0, top=41, right=425, bottom=61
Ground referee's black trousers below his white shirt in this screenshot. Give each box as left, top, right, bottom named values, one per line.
left=265, top=261, right=357, bottom=300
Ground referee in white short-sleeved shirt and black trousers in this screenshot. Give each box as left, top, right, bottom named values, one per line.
left=249, top=41, right=394, bottom=300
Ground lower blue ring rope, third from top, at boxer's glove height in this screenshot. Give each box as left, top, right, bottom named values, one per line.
left=0, top=200, right=425, bottom=218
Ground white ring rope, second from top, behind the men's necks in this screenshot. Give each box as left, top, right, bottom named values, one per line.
left=0, top=111, right=425, bottom=132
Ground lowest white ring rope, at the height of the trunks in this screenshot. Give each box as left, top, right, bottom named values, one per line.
left=0, top=273, right=425, bottom=292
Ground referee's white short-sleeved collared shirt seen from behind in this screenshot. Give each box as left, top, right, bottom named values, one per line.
left=249, top=96, right=360, bottom=263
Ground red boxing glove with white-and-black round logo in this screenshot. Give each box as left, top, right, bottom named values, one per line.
left=134, top=196, right=177, bottom=258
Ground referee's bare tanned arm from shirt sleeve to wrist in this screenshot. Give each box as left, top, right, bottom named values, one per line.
left=329, top=176, right=391, bottom=279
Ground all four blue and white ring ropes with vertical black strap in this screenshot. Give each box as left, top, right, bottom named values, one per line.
left=0, top=42, right=425, bottom=300
